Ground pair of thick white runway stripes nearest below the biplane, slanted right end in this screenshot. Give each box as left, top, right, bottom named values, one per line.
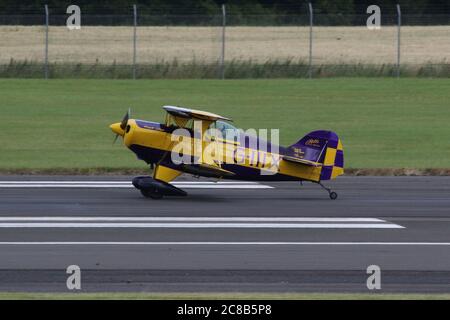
left=0, top=217, right=404, bottom=229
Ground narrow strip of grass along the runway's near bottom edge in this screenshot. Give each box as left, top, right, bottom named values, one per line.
left=0, top=292, right=450, bottom=300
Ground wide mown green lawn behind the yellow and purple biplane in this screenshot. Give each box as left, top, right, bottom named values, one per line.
left=0, top=78, right=450, bottom=171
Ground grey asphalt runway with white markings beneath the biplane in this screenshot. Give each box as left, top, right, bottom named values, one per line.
left=0, top=176, right=450, bottom=293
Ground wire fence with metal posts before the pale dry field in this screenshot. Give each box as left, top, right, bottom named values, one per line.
left=0, top=5, right=450, bottom=79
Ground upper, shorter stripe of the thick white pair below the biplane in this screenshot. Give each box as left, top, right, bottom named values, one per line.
left=0, top=216, right=386, bottom=223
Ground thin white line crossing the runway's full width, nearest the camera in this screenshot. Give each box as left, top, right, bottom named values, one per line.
left=0, top=241, right=444, bottom=247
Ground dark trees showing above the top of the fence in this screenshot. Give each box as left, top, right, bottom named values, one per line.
left=0, top=0, right=450, bottom=15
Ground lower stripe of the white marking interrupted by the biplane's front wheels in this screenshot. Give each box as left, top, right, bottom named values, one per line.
left=0, top=183, right=273, bottom=189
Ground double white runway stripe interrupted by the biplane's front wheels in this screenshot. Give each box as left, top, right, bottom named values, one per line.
left=0, top=181, right=273, bottom=189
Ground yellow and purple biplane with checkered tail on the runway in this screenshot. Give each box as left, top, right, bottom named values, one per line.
left=110, top=106, right=344, bottom=200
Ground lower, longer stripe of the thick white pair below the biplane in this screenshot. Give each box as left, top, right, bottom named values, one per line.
left=0, top=222, right=403, bottom=229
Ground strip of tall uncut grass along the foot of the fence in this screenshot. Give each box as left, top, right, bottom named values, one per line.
left=0, top=59, right=450, bottom=79
